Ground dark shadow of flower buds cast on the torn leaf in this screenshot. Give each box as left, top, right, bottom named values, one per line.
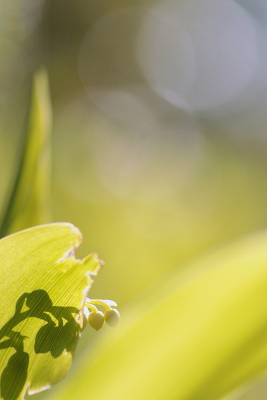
left=0, top=289, right=80, bottom=400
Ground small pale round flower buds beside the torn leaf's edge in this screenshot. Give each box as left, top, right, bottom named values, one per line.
left=83, top=298, right=121, bottom=331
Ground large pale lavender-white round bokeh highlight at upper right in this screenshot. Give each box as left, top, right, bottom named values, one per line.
left=137, top=0, right=259, bottom=110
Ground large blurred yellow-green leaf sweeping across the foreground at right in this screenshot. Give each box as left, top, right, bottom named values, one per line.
left=49, top=231, right=267, bottom=400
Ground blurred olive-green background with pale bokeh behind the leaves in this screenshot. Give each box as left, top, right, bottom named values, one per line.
left=0, top=0, right=267, bottom=400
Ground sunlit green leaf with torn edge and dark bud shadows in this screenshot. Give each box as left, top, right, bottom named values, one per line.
left=0, top=223, right=102, bottom=400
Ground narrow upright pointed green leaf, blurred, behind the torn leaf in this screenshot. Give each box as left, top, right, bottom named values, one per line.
left=0, top=69, right=51, bottom=237
